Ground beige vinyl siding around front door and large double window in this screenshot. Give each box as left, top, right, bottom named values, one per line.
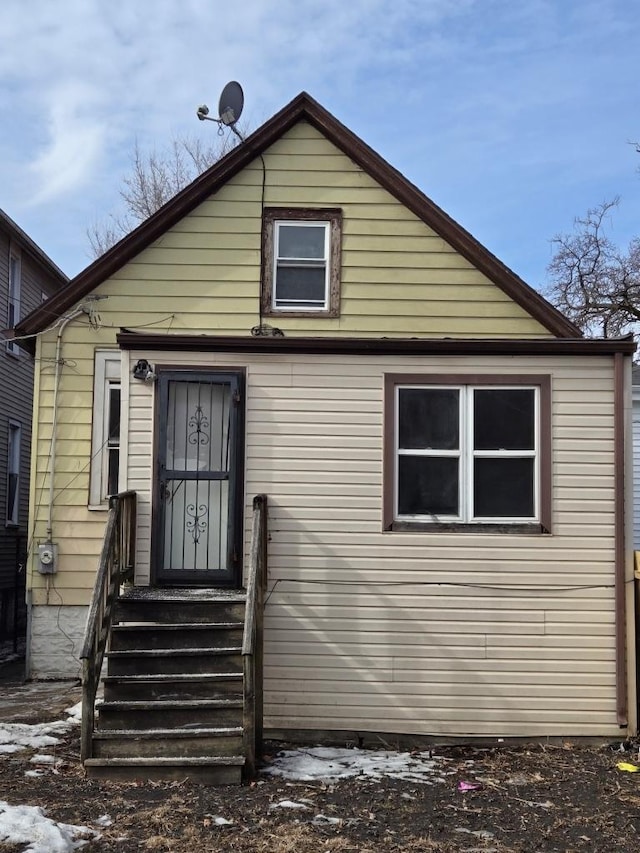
left=114, top=352, right=620, bottom=737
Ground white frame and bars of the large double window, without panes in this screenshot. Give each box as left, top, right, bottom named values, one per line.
left=393, top=383, right=541, bottom=525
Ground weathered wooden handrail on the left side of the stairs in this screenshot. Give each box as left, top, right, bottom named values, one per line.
left=80, top=492, right=136, bottom=761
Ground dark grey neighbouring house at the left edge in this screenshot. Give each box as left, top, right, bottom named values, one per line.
left=0, top=210, right=68, bottom=638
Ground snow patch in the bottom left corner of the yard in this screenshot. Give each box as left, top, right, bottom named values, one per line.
left=0, top=800, right=100, bottom=853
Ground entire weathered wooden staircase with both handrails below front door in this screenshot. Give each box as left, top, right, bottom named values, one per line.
left=81, top=493, right=266, bottom=785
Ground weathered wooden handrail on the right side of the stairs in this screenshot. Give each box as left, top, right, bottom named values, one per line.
left=242, top=495, right=267, bottom=777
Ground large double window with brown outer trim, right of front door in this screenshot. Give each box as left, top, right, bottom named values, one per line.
left=385, top=376, right=550, bottom=530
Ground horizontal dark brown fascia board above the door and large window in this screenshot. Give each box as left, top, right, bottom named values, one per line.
left=117, top=329, right=636, bottom=356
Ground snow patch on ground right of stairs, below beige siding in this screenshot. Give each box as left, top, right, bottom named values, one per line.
left=263, top=746, right=444, bottom=785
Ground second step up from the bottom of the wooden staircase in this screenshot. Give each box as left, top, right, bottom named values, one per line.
left=93, top=726, right=243, bottom=758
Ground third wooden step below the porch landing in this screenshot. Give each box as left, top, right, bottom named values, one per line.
left=103, top=672, right=242, bottom=702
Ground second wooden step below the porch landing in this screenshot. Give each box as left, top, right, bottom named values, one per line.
left=107, top=645, right=242, bottom=675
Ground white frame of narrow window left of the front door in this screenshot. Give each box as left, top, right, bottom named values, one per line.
left=89, top=350, right=122, bottom=509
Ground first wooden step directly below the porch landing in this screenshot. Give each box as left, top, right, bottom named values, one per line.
left=111, top=622, right=244, bottom=651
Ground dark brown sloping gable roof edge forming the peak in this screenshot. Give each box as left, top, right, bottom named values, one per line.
left=18, top=92, right=582, bottom=338
